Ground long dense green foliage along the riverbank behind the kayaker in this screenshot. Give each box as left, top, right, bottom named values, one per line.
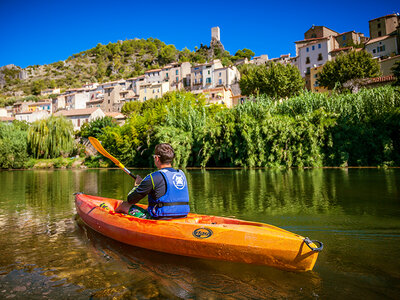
left=89, top=86, right=400, bottom=168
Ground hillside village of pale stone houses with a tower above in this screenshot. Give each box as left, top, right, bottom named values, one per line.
left=0, top=14, right=400, bottom=130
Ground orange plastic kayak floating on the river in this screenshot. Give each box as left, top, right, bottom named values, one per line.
left=75, top=193, right=323, bottom=271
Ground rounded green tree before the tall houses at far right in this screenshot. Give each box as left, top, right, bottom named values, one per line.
left=318, top=51, right=380, bottom=89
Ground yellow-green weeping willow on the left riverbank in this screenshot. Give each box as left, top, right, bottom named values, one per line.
left=28, top=116, right=74, bottom=158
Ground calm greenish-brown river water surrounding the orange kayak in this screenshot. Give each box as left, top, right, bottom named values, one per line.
left=0, top=169, right=400, bottom=299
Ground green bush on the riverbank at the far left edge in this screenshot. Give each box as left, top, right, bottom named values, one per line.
left=0, top=123, right=29, bottom=169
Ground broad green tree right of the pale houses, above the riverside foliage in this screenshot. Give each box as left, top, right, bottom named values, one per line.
left=239, top=62, right=304, bottom=99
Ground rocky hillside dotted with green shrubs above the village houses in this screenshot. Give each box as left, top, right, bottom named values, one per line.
left=0, top=38, right=250, bottom=97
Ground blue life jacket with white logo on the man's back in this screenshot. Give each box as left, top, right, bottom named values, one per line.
left=148, top=169, right=190, bottom=218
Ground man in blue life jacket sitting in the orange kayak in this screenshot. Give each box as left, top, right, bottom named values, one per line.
left=115, top=143, right=190, bottom=219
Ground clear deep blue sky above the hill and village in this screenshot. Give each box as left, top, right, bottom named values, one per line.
left=0, top=0, right=400, bottom=68
